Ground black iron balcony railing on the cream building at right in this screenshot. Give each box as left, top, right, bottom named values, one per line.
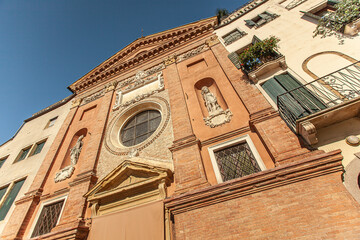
left=277, top=61, right=360, bottom=130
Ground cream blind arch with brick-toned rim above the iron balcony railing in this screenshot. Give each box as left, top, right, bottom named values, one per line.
left=302, top=51, right=357, bottom=79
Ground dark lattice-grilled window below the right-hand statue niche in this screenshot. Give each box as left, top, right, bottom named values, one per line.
left=214, top=142, right=261, bottom=182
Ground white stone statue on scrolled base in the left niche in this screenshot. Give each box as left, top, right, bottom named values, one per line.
left=54, top=135, right=84, bottom=182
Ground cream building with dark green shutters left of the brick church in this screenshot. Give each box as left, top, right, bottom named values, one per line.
left=0, top=96, right=73, bottom=235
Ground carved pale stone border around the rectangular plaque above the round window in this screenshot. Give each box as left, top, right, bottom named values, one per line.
left=113, top=72, right=165, bottom=110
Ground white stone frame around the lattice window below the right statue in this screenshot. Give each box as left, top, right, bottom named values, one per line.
left=208, top=134, right=267, bottom=183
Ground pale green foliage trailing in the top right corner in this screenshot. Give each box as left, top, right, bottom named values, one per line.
left=314, top=0, right=360, bottom=37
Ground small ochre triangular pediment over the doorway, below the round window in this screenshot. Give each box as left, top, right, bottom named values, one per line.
left=85, top=160, right=172, bottom=202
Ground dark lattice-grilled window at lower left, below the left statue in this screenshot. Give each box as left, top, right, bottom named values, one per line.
left=31, top=200, right=64, bottom=237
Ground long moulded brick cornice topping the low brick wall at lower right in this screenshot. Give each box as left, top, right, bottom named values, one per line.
left=164, top=150, right=343, bottom=214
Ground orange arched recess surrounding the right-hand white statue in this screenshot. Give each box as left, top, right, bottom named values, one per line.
left=194, top=78, right=228, bottom=118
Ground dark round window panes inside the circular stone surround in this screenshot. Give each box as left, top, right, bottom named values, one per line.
left=120, top=110, right=161, bottom=147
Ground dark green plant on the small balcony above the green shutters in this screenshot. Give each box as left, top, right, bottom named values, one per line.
left=239, top=36, right=280, bottom=71
